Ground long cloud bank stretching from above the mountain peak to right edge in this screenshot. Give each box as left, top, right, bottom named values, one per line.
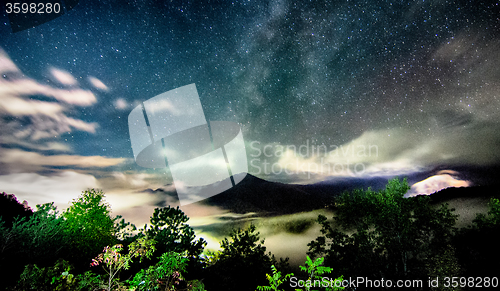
left=262, top=120, right=500, bottom=183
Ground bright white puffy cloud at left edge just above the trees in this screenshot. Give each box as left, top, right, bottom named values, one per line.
left=0, top=171, right=99, bottom=209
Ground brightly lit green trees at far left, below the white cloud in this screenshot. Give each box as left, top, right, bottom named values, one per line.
left=0, top=189, right=143, bottom=285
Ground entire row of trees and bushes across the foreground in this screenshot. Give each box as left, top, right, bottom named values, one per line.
left=7, top=179, right=500, bottom=291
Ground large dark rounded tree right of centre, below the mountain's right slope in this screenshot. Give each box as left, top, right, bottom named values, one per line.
left=309, top=179, right=457, bottom=279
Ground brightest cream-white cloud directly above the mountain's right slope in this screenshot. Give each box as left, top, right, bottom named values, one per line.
left=262, top=130, right=422, bottom=183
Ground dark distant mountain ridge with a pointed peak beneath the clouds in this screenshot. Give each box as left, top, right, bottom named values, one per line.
left=145, top=174, right=500, bottom=216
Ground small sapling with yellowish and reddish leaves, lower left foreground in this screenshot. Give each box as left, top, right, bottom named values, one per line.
left=91, top=237, right=155, bottom=291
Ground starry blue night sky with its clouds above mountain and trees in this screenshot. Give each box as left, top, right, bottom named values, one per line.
left=0, top=0, right=500, bottom=224
